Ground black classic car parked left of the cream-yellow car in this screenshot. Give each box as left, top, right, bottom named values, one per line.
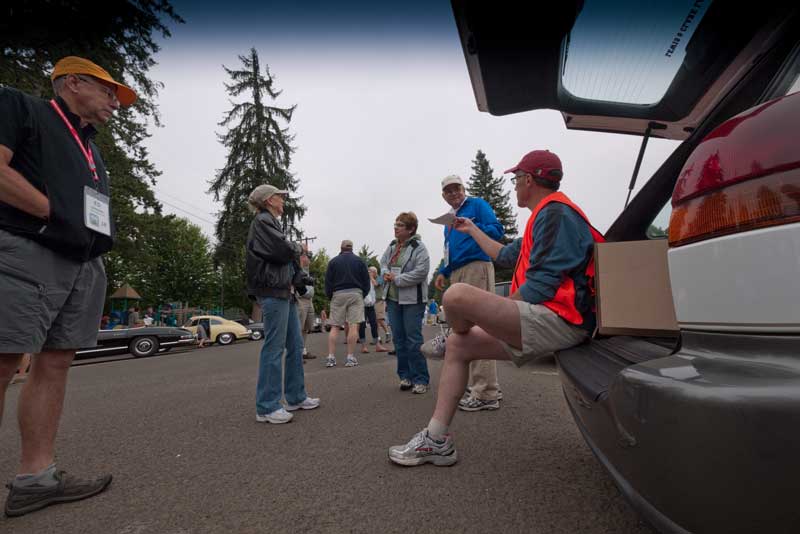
left=75, top=326, right=195, bottom=358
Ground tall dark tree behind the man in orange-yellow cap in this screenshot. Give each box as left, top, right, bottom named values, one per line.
left=0, top=0, right=183, bottom=300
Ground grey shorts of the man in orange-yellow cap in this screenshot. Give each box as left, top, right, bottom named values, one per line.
left=0, top=230, right=106, bottom=354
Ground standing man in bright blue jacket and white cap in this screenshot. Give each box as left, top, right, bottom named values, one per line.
left=422, top=175, right=504, bottom=412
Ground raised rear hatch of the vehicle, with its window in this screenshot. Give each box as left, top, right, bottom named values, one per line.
left=452, top=0, right=796, bottom=140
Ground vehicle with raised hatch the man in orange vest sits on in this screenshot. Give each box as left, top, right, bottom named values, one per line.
left=452, top=0, right=800, bottom=533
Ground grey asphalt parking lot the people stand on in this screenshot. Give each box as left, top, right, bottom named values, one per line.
left=0, top=328, right=653, bottom=534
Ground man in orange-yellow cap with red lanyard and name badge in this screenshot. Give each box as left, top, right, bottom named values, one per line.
left=0, top=56, right=136, bottom=516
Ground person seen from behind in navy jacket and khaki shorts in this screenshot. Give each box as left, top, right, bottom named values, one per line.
left=325, top=239, right=371, bottom=367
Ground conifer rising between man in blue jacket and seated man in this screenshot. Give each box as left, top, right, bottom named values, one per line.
left=467, top=150, right=518, bottom=282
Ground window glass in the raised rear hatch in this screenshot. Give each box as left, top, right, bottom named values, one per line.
left=561, top=0, right=711, bottom=105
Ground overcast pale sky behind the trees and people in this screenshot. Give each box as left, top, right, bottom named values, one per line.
left=142, top=1, right=676, bottom=268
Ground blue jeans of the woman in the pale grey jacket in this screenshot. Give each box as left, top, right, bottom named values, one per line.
left=386, top=300, right=430, bottom=385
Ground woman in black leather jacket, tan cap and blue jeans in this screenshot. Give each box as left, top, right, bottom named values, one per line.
left=245, top=184, right=319, bottom=424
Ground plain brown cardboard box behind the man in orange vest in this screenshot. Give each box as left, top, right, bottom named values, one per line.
left=595, top=239, right=678, bottom=336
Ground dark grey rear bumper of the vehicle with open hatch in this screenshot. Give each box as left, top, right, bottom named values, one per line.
left=561, top=332, right=800, bottom=532
